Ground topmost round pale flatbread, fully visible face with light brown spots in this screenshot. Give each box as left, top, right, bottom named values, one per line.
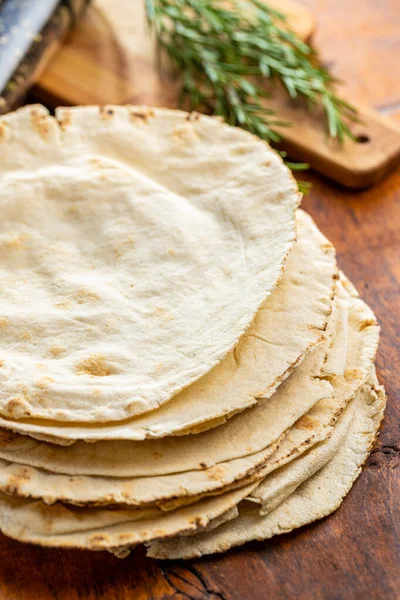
left=0, top=106, right=299, bottom=424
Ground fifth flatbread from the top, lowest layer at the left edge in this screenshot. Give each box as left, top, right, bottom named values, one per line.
left=0, top=484, right=256, bottom=552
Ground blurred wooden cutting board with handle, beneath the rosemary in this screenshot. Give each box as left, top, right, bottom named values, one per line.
left=34, top=0, right=400, bottom=188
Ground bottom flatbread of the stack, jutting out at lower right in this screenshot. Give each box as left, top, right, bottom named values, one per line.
left=148, top=376, right=385, bottom=559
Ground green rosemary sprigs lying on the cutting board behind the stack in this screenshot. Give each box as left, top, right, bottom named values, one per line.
left=146, top=0, right=355, bottom=188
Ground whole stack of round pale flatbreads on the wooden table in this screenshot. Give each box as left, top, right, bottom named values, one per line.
left=0, top=106, right=385, bottom=558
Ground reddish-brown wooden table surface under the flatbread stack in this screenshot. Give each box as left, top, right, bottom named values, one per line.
left=0, top=0, right=400, bottom=600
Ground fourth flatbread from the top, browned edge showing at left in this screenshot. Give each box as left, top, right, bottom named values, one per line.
left=0, top=436, right=283, bottom=510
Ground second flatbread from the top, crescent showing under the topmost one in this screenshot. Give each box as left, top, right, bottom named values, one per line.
left=0, top=211, right=336, bottom=443
